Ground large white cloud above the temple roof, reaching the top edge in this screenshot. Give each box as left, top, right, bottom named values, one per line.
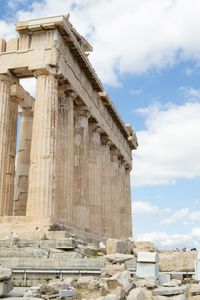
left=1, top=0, right=200, bottom=84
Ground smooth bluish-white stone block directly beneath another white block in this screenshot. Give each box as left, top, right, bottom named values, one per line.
left=136, top=263, right=159, bottom=279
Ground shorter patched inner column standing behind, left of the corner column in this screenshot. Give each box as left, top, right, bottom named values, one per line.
left=13, top=108, right=33, bottom=216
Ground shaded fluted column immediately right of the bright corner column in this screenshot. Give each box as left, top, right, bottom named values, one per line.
left=56, top=86, right=76, bottom=226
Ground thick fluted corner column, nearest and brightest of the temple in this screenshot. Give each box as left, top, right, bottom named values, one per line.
left=27, top=74, right=58, bottom=217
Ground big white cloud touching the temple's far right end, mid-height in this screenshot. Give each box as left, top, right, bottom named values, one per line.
left=132, top=102, right=200, bottom=186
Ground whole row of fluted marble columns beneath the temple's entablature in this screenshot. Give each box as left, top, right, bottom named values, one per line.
left=0, top=73, right=131, bottom=237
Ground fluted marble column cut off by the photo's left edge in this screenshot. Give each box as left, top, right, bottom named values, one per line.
left=0, top=75, right=12, bottom=216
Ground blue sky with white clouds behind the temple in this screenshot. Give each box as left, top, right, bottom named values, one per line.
left=0, top=0, right=200, bottom=249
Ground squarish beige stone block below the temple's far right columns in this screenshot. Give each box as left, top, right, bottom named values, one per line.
left=106, top=239, right=130, bottom=254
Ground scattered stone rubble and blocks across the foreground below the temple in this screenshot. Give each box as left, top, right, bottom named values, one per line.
left=0, top=234, right=200, bottom=300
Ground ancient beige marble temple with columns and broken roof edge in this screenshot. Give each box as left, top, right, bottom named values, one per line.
left=0, top=16, right=137, bottom=237
